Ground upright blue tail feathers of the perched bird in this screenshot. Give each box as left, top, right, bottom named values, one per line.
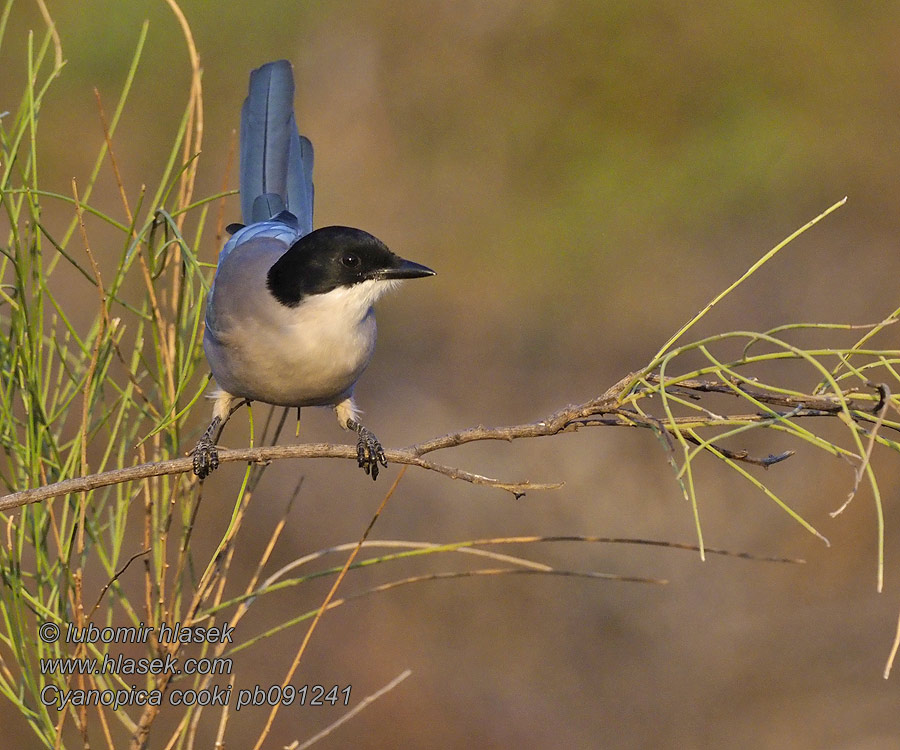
left=241, top=60, right=313, bottom=234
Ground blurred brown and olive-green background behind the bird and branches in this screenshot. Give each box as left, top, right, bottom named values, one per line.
left=0, top=0, right=900, bottom=750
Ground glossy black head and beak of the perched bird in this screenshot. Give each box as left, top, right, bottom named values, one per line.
left=266, top=227, right=434, bottom=307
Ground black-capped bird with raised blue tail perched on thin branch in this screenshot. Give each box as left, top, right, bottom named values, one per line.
left=191, top=60, right=435, bottom=481
